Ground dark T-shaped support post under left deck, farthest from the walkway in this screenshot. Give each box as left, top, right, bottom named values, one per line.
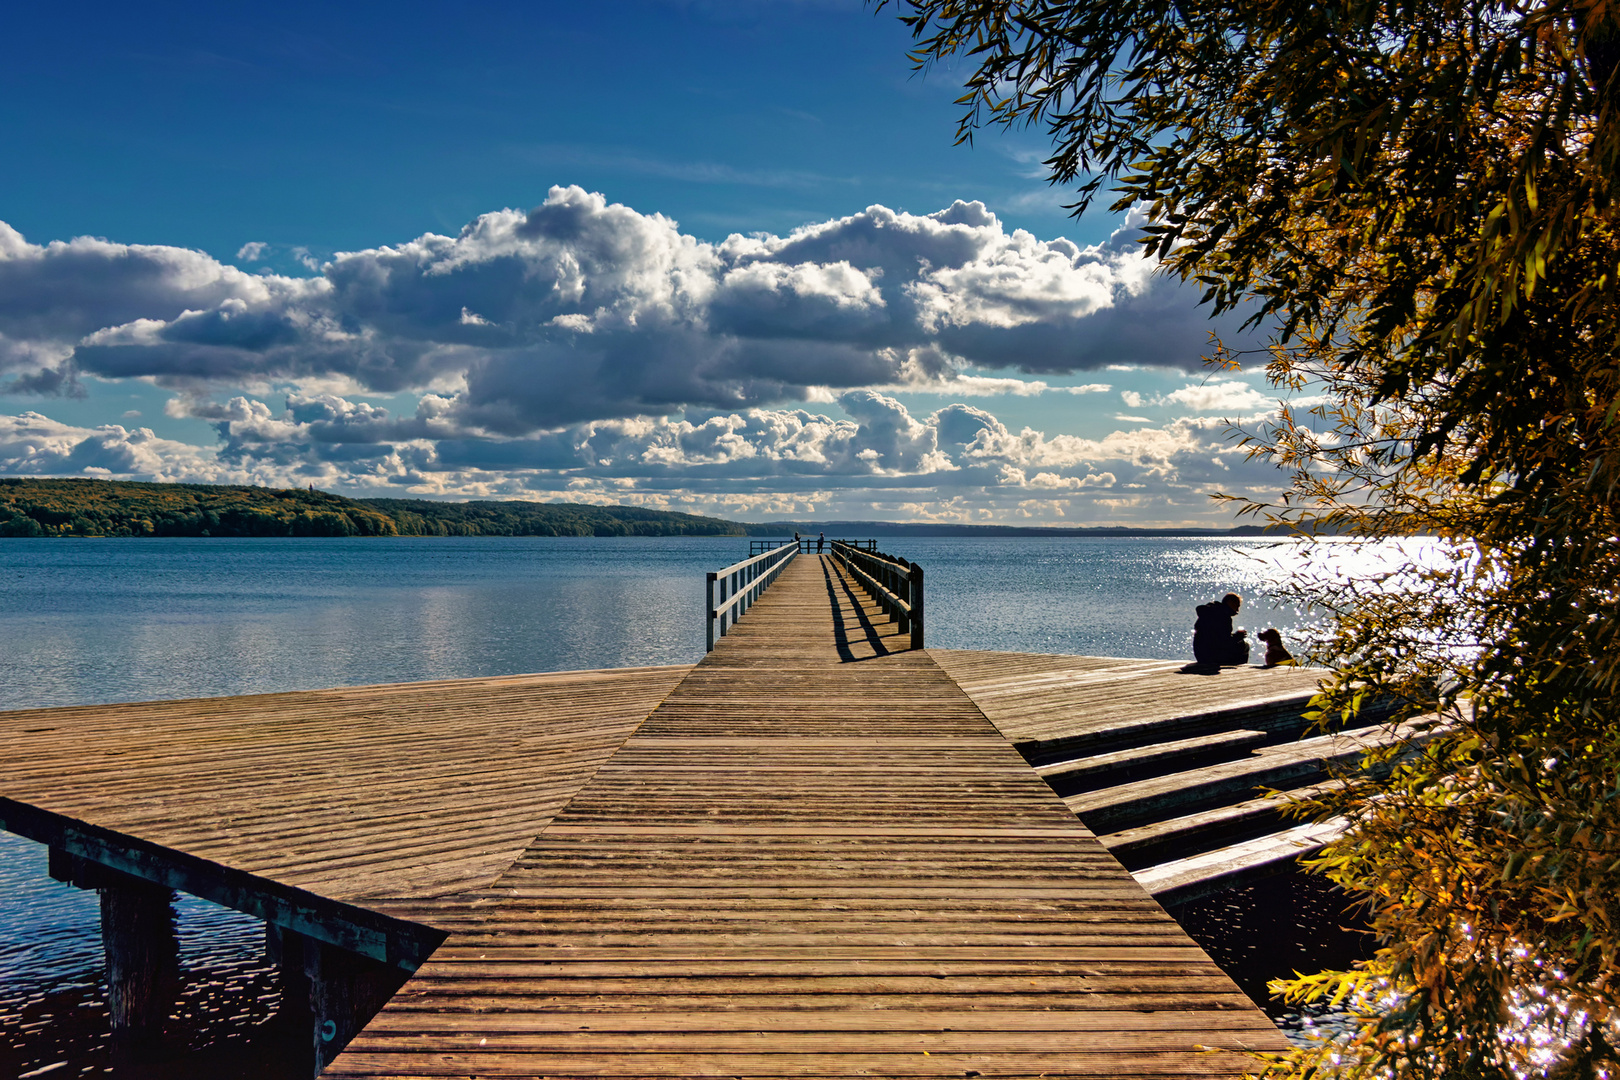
left=49, top=847, right=180, bottom=1061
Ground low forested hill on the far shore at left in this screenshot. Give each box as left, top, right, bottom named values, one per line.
left=0, top=478, right=745, bottom=538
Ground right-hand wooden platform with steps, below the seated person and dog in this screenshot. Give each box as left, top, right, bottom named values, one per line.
left=932, top=649, right=1411, bottom=905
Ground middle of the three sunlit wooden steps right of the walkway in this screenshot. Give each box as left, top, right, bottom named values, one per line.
left=1063, top=725, right=1418, bottom=834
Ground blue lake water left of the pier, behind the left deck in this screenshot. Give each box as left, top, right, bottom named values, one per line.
left=0, top=538, right=729, bottom=708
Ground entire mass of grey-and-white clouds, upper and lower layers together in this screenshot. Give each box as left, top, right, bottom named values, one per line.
left=0, top=188, right=1283, bottom=520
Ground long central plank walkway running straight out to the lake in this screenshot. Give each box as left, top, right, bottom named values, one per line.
left=326, top=559, right=1285, bottom=1080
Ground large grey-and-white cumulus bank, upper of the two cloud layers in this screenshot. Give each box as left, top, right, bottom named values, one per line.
left=0, top=188, right=1250, bottom=436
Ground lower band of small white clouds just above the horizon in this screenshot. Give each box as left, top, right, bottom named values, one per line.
left=0, top=390, right=1275, bottom=523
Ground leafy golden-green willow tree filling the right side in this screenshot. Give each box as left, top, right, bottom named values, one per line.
left=901, top=0, right=1620, bottom=1077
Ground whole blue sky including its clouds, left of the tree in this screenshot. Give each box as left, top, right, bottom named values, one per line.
left=0, top=0, right=1278, bottom=525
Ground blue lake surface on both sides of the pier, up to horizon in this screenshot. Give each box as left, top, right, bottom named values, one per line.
left=0, top=538, right=1440, bottom=709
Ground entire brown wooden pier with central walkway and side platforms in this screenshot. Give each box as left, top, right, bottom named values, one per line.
left=0, top=555, right=1367, bottom=1080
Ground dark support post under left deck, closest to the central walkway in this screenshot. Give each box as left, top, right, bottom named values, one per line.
left=275, top=926, right=410, bottom=1077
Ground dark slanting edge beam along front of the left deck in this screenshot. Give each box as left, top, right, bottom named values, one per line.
left=0, top=798, right=449, bottom=972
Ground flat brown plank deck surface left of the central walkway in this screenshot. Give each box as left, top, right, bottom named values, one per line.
left=0, top=665, right=690, bottom=902
